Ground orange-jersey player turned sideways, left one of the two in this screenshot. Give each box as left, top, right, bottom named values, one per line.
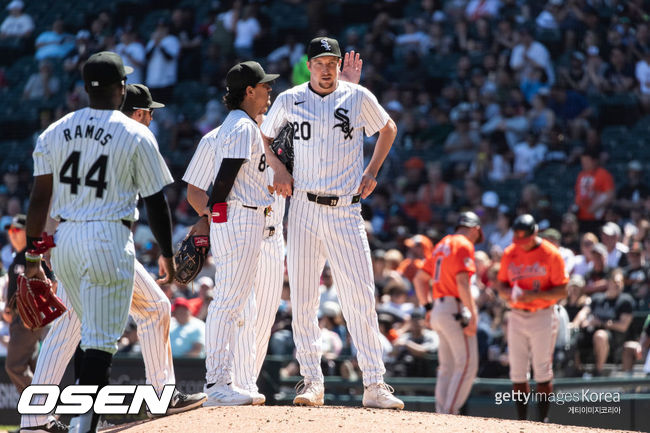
left=413, top=212, right=483, bottom=414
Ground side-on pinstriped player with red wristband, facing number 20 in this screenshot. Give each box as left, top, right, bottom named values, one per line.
left=183, top=62, right=278, bottom=406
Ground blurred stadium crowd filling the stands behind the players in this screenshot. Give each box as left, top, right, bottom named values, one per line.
left=0, top=0, right=650, bottom=378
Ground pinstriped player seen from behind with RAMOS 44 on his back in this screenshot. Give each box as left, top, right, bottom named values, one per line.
left=23, top=52, right=174, bottom=432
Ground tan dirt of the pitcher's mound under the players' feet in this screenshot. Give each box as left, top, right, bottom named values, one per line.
left=102, top=406, right=622, bottom=433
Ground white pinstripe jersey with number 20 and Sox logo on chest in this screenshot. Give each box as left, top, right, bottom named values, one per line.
left=261, top=81, right=390, bottom=196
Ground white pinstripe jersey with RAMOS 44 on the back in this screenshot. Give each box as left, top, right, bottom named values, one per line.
left=33, top=108, right=174, bottom=221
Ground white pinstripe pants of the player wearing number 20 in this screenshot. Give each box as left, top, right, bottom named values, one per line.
left=287, top=194, right=386, bottom=386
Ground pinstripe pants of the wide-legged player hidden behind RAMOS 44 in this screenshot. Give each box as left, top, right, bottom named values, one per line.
left=22, top=261, right=176, bottom=427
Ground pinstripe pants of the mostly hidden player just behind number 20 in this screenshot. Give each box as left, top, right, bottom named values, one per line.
left=233, top=227, right=284, bottom=391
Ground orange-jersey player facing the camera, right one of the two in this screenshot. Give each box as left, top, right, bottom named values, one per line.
left=498, top=214, right=569, bottom=421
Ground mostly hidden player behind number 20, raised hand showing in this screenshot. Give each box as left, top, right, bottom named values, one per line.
left=233, top=51, right=363, bottom=405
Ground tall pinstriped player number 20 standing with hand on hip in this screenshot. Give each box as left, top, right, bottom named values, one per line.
left=262, top=37, right=404, bottom=409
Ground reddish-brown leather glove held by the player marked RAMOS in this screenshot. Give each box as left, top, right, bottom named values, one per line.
left=16, top=274, right=67, bottom=329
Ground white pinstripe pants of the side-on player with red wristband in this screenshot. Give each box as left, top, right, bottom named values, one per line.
left=205, top=202, right=265, bottom=384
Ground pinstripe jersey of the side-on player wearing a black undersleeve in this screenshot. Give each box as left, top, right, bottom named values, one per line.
left=183, top=110, right=274, bottom=206
